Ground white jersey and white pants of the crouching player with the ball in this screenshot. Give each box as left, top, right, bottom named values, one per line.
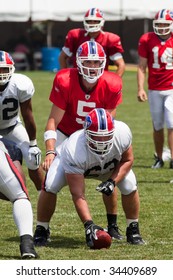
left=44, top=121, right=136, bottom=194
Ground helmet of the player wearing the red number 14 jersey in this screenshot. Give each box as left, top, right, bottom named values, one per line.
left=153, top=9, right=173, bottom=36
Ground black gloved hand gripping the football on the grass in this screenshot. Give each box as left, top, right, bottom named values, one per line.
left=84, top=221, right=104, bottom=248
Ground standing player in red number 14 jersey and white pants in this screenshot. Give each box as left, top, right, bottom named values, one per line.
left=137, top=9, right=173, bottom=169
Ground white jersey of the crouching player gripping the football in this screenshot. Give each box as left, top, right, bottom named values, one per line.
left=61, top=121, right=132, bottom=180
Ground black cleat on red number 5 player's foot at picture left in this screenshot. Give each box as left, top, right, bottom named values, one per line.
left=34, top=225, right=50, bottom=247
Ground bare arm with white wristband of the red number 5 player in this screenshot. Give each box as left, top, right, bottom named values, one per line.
left=43, top=104, right=65, bottom=171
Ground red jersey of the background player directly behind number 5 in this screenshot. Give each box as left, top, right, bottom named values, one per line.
left=64, top=28, right=124, bottom=70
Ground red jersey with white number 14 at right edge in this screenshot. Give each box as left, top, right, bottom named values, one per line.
left=138, top=32, right=173, bottom=90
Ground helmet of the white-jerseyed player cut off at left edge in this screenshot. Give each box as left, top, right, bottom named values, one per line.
left=0, top=51, right=15, bottom=85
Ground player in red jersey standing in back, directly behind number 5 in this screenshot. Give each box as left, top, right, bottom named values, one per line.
left=59, top=8, right=125, bottom=76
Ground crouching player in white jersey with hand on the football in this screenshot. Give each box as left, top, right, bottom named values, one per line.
left=36, top=108, right=144, bottom=248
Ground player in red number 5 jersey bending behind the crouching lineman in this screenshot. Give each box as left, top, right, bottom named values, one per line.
left=34, top=41, right=122, bottom=246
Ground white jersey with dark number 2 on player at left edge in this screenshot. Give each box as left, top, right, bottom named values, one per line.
left=0, top=73, right=35, bottom=130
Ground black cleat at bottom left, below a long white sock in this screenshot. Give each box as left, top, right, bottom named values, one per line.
left=20, top=234, right=38, bottom=259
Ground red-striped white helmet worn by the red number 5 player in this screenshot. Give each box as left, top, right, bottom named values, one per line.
left=76, top=41, right=106, bottom=83
